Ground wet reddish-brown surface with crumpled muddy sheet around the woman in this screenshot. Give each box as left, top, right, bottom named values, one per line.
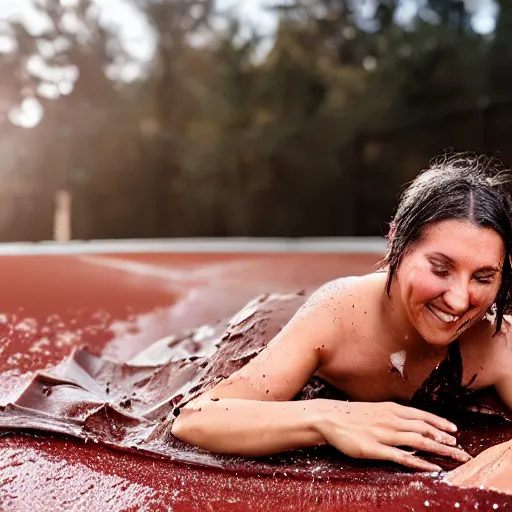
left=0, top=250, right=512, bottom=510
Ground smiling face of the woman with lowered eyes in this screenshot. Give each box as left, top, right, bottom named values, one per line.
left=397, top=220, right=505, bottom=346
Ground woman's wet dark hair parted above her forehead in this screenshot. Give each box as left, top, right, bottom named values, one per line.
left=382, top=152, right=512, bottom=332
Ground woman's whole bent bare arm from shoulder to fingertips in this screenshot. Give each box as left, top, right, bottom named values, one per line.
left=172, top=280, right=468, bottom=471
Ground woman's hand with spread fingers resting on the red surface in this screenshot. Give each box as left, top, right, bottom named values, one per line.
left=316, top=400, right=471, bottom=471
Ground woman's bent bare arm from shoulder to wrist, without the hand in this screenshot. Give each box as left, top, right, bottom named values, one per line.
left=172, top=282, right=336, bottom=448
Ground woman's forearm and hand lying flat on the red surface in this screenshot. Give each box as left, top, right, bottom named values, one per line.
left=172, top=398, right=470, bottom=471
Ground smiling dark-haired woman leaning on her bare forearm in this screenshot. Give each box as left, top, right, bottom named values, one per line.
left=172, top=153, right=512, bottom=471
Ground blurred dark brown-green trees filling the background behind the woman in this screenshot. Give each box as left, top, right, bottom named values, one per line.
left=0, top=0, right=506, bottom=241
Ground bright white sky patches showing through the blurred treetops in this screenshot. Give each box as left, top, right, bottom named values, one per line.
left=0, top=0, right=496, bottom=128
